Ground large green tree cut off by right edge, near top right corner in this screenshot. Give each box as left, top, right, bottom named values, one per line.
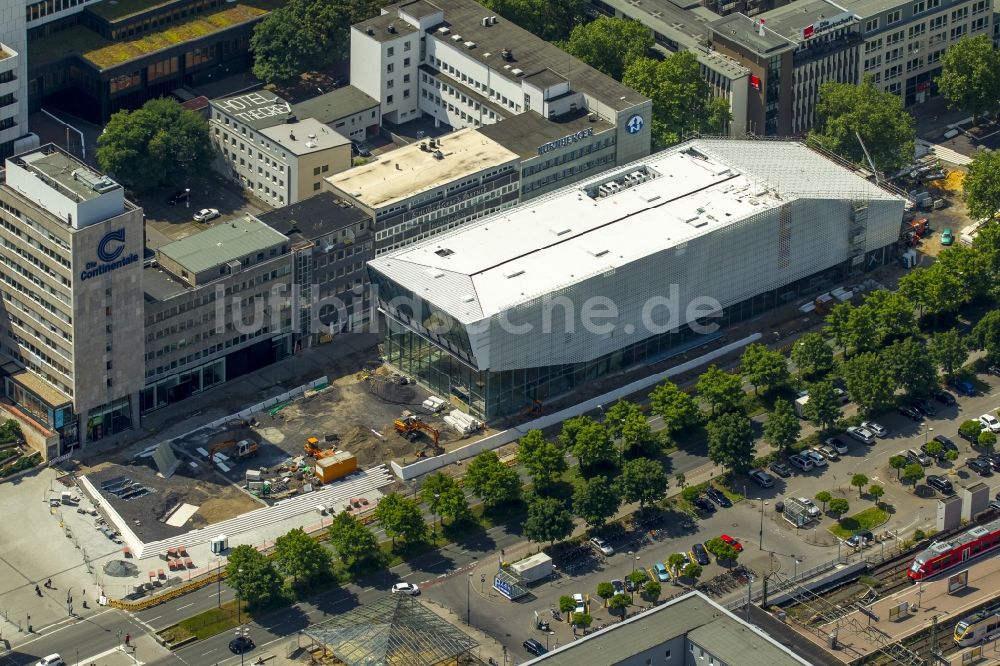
left=937, top=34, right=1000, bottom=120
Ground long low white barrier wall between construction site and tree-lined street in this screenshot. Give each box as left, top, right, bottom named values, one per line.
left=389, top=333, right=761, bottom=481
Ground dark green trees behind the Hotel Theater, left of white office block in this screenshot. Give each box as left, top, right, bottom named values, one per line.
left=250, top=0, right=381, bottom=83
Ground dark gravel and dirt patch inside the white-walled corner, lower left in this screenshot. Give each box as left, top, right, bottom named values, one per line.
left=80, top=458, right=263, bottom=541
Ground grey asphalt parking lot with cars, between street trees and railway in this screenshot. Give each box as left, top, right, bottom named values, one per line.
left=425, top=376, right=1000, bottom=660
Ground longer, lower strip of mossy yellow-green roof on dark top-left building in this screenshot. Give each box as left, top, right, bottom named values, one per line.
left=28, top=0, right=276, bottom=69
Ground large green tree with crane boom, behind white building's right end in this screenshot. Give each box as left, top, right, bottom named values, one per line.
left=810, top=79, right=916, bottom=173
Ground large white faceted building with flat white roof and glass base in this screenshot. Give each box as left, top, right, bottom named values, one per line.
left=368, top=139, right=904, bottom=419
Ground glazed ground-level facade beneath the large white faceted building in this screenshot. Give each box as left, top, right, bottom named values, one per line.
left=382, top=250, right=888, bottom=421
